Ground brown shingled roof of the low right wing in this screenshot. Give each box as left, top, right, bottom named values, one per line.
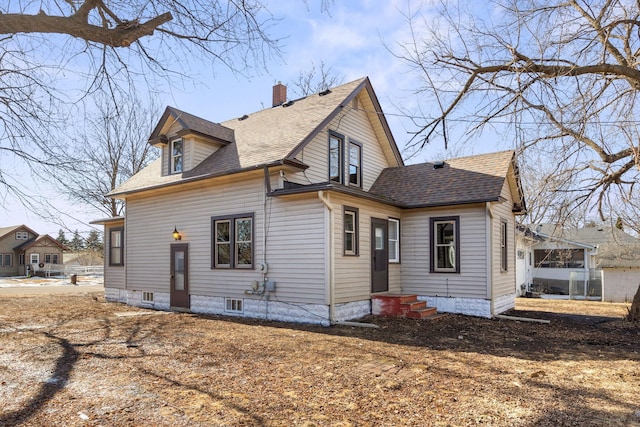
left=369, top=151, right=524, bottom=209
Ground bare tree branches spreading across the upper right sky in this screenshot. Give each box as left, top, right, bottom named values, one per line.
left=395, top=0, right=640, bottom=230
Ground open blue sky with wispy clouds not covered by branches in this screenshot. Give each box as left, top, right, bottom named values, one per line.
left=0, top=0, right=507, bottom=237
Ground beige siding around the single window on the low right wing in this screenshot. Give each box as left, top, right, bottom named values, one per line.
left=401, top=205, right=489, bottom=299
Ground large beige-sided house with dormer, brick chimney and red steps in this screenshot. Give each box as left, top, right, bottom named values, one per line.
left=95, top=78, right=524, bottom=325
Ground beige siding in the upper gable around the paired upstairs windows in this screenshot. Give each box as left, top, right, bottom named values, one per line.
left=289, top=98, right=395, bottom=190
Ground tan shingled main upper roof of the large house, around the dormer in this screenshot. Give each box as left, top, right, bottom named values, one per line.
left=108, top=77, right=403, bottom=196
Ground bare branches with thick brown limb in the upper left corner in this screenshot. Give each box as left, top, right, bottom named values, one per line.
left=0, top=0, right=280, bottom=204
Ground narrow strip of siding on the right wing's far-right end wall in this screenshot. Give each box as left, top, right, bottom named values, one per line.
left=491, top=180, right=516, bottom=297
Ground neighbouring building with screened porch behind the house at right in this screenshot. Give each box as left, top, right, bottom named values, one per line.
left=517, top=224, right=640, bottom=302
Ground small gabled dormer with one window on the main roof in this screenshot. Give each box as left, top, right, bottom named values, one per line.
left=149, top=107, right=235, bottom=176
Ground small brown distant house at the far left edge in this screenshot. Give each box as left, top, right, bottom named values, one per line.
left=0, top=225, right=66, bottom=277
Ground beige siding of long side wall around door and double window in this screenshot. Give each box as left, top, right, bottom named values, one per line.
left=126, top=171, right=326, bottom=303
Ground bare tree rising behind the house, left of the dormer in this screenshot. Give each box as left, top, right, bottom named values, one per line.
left=58, top=95, right=160, bottom=216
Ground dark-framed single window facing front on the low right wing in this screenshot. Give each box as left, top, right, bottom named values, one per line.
left=430, top=217, right=460, bottom=273
